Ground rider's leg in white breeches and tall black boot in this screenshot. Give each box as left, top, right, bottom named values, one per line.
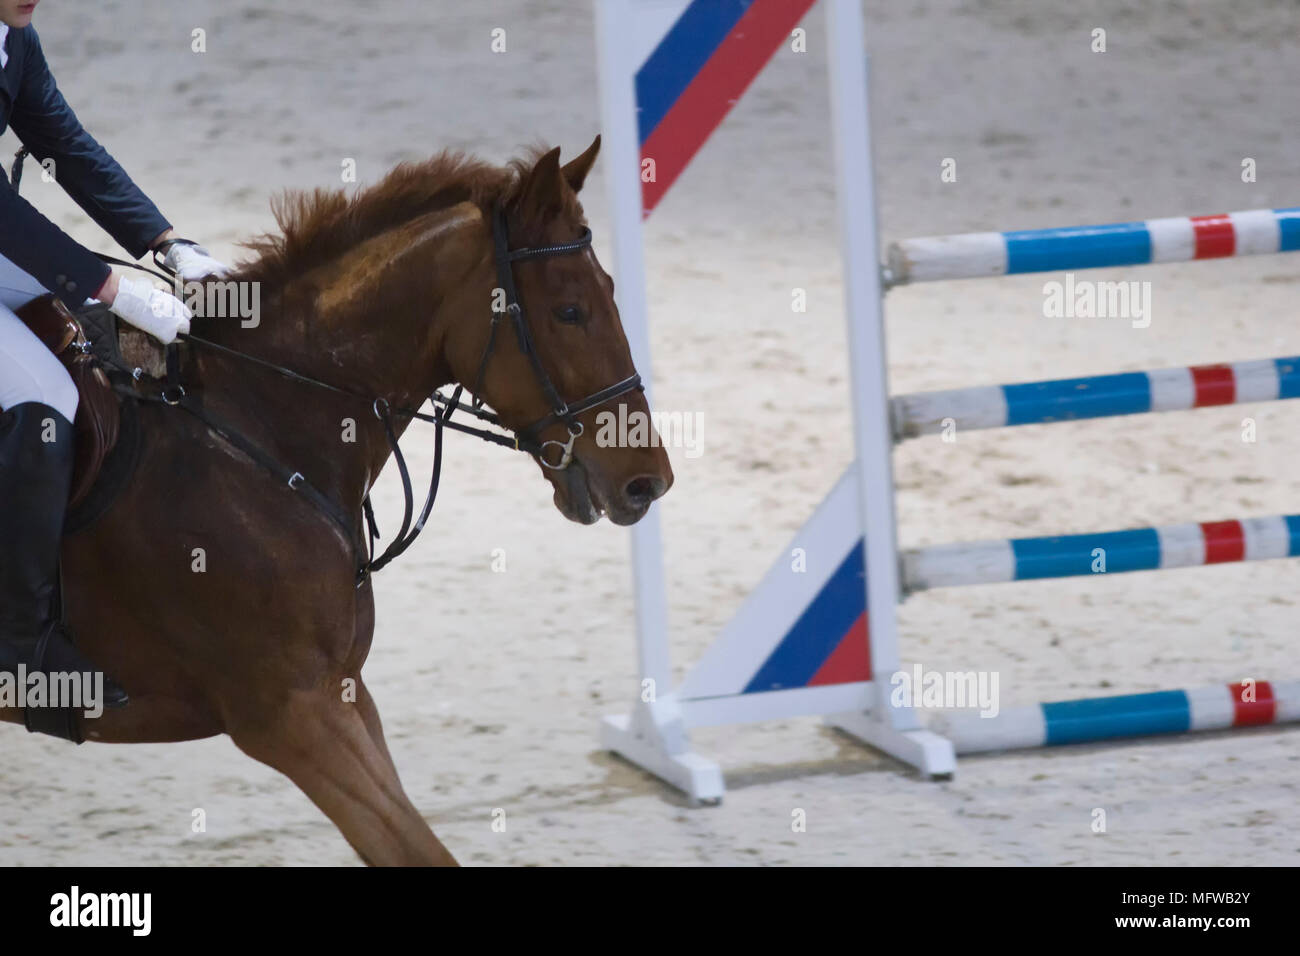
left=0, top=256, right=126, bottom=730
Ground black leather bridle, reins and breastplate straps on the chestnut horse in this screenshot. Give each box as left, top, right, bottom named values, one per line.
left=101, top=204, right=645, bottom=587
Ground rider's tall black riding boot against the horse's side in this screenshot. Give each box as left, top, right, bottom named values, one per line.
left=0, top=402, right=127, bottom=743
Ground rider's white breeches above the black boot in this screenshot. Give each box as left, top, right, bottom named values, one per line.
left=0, top=255, right=77, bottom=421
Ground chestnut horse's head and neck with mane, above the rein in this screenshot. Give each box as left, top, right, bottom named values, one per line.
left=230, top=137, right=672, bottom=524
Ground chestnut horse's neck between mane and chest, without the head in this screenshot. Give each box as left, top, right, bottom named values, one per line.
left=199, top=207, right=491, bottom=510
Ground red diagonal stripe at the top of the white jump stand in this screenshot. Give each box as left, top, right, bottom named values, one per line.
left=641, top=0, right=815, bottom=216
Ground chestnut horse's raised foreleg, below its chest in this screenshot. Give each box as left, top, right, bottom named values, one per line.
left=230, top=693, right=456, bottom=866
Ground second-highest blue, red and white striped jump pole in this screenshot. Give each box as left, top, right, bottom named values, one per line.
left=889, top=355, right=1300, bottom=441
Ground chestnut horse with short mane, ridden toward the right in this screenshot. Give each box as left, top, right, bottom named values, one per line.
left=0, top=138, right=672, bottom=865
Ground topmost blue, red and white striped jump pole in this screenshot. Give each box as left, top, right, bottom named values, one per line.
left=888, top=207, right=1300, bottom=285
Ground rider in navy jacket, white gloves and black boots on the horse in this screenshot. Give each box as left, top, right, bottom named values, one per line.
left=0, top=0, right=226, bottom=730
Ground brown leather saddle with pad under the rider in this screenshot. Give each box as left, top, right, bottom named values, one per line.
left=17, top=295, right=163, bottom=523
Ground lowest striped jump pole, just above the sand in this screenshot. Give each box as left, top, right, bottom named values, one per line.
left=931, top=680, right=1300, bottom=753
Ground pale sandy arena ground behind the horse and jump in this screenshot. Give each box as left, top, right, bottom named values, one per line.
left=0, top=0, right=1300, bottom=865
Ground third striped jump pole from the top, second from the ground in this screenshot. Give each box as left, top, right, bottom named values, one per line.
left=902, top=515, right=1300, bottom=592
